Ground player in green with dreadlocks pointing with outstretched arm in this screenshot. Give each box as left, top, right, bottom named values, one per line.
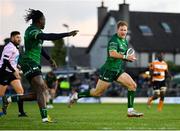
left=2, top=9, right=78, bottom=122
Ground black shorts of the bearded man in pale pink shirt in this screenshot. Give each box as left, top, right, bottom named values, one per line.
left=0, top=69, right=17, bottom=86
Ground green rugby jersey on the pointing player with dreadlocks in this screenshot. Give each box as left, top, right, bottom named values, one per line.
left=22, top=24, right=43, bottom=64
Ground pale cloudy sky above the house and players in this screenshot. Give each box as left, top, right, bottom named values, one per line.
left=0, top=0, right=180, bottom=47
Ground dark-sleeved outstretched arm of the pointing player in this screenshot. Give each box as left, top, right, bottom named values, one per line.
left=37, top=30, right=78, bottom=40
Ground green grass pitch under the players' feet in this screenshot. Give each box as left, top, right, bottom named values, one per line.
left=0, top=102, right=180, bottom=130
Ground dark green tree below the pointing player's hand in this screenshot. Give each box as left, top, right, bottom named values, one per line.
left=51, top=39, right=66, bottom=66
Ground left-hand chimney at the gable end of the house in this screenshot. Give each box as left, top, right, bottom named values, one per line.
left=98, top=1, right=107, bottom=29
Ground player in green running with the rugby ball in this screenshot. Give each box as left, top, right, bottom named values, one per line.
left=69, top=21, right=143, bottom=117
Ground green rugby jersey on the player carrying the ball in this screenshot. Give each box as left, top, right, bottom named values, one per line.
left=102, top=34, right=128, bottom=71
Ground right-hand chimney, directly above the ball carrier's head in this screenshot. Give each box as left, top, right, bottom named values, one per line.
left=119, top=0, right=129, bottom=24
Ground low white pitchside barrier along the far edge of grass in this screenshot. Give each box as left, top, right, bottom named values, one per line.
left=54, top=96, right=180, bottom=104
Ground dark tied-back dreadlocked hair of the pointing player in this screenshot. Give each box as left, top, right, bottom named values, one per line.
left=25, top=9, right=44, bottom=23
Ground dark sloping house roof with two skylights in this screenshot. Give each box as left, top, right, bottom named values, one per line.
left=86, top=11, right=180, bottom=53
